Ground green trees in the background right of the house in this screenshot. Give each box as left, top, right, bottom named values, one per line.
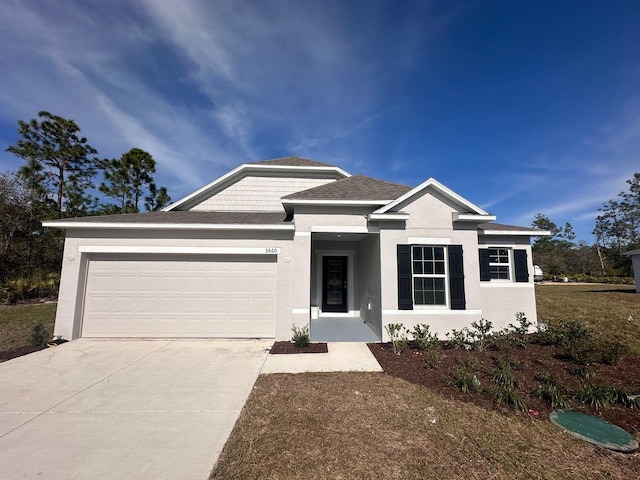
left=532, top=173, right=640, bottom=280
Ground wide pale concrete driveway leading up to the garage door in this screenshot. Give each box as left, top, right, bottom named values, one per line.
left=0, top=339, right=272, bottom=480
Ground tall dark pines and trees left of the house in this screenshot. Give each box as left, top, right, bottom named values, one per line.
left=0, top=111, right=171, bottom=284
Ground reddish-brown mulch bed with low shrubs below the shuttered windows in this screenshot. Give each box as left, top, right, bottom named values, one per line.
left=369, top=343, right=640, bottom=435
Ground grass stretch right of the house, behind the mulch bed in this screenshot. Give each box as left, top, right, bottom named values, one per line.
left=536, top=284, right=640, bottom=355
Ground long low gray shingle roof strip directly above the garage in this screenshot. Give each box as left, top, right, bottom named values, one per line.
left=46, top=210, right=287, bottom=225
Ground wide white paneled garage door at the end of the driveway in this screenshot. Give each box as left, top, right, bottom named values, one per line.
left=82, top=255, right=276, bottom=338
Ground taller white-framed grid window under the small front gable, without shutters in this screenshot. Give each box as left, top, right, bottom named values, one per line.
left=411, top=245, right=447, bottom=305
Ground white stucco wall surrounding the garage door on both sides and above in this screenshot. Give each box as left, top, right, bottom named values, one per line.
left=54, top=230, right=298, bottom=340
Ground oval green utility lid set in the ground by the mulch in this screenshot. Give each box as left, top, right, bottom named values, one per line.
left=549, top=410, right=638, bottom=453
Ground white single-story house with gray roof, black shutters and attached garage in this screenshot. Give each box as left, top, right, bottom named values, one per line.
left=44, top=157, right=548, bottom=341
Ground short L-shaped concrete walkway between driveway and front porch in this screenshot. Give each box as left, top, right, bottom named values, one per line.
left=260, top=342, right=382, bottom=373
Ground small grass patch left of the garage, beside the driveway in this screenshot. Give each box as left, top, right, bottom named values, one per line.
left=0, top=303, right=57, bottom=350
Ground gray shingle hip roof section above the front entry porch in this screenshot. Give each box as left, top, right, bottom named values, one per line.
left=283, top=175, right=411, bottom=200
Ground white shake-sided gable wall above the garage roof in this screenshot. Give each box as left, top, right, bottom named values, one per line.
left=191, top=175, right=335, bottom=211
